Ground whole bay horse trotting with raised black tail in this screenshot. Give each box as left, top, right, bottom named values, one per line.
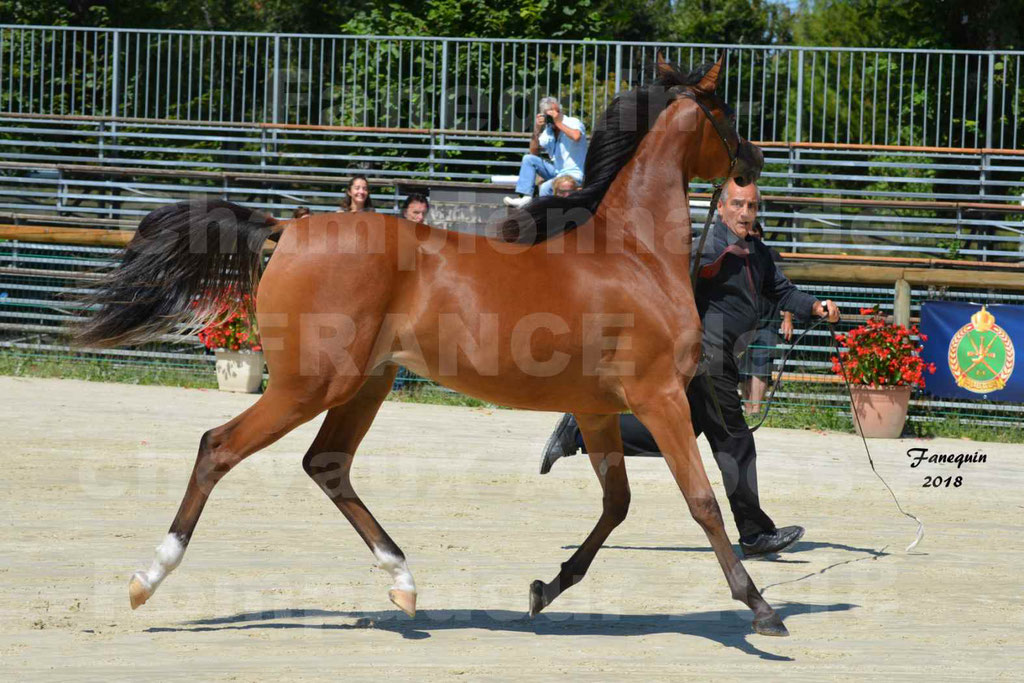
left=77, top=59, right=787, bottom=636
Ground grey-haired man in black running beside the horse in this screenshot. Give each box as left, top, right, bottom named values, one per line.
left=541, top=180, right=840, bottom=557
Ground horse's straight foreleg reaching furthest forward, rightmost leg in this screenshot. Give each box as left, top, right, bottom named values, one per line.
left=633, top=390, right=788, bottom=636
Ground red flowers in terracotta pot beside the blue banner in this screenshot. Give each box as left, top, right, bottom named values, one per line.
left=831, top=306, right=935, bottom=438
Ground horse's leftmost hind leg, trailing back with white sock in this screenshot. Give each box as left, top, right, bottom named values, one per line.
left=128, top=383, right=324, bottom=609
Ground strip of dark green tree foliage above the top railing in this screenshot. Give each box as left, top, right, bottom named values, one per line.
left=0, top=0, right=1024, bottom=49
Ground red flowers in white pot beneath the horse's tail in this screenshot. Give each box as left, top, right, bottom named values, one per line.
left=193, top=295, right=263, bottom=393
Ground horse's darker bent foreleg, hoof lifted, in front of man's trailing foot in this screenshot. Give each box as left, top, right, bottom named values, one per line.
left=529, top=415, right=630, bottom=616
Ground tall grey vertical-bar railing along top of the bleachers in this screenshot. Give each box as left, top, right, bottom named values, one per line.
left=0, top=26, right=1024, bottom=148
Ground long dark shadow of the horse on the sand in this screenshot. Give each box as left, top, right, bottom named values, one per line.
left=146, top=602, right=857, bottom=661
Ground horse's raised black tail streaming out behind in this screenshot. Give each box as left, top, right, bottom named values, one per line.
left=75, top=200, right=281, bottom=346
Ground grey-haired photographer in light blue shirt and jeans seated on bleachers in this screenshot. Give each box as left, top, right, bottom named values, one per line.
left=505, top=97, right=587, bottom=209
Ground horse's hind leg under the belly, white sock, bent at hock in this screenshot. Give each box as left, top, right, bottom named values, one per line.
left=302, top=366, right=416, bottom=616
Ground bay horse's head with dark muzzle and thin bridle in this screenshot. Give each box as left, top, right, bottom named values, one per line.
left=666, top=55, right=764, bottom=186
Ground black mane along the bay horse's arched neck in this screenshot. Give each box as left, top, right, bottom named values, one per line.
left=497, top=60, right=714, bottom=244
